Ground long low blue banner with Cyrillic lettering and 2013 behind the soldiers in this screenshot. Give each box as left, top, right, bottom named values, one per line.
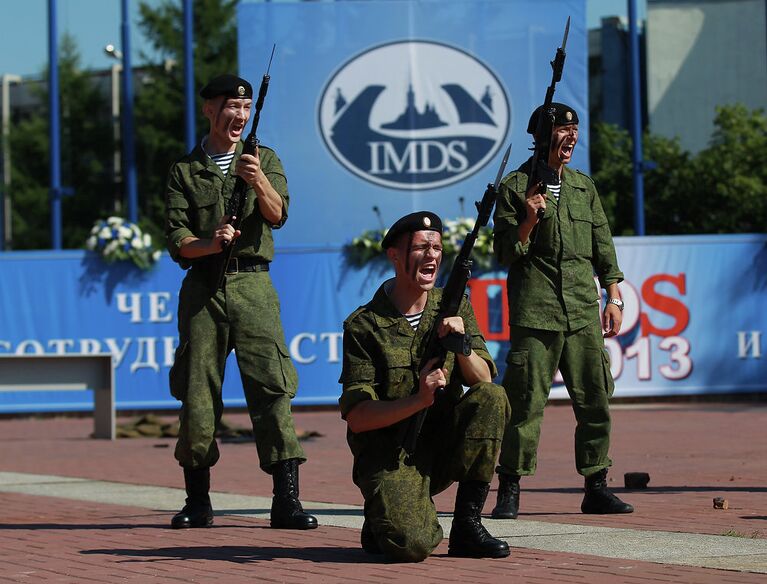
left=0, top=235, right=767, bottom=413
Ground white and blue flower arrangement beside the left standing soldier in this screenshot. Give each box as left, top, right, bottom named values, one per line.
left=85, top=217, right=161, bottom=270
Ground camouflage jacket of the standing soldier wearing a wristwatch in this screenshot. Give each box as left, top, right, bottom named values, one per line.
left=493, top=160, right=623, bottom=331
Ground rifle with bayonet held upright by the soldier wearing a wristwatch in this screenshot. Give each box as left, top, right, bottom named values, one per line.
left=527, top=16, right=570, bottom=224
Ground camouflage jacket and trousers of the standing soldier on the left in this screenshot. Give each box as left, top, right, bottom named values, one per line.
left=165, top=142, right=305, bottom=469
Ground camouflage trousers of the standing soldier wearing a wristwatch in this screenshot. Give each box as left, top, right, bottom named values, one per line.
left=497, top=321, right=614, bottom=476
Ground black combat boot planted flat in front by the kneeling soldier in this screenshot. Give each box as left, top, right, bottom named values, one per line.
left=447, top=481, right=509, bottom=558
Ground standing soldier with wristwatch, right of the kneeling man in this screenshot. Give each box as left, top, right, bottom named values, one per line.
left=492, top=103, right=634, bottom=519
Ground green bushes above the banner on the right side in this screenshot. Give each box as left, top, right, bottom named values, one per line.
left=591, top=105, right=767, bottom=235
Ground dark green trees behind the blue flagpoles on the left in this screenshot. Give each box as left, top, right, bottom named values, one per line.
left=10, top=0, right=237, bottom=249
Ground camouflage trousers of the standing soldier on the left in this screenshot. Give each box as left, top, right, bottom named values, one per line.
left=170, top=270, right=305, bottom=470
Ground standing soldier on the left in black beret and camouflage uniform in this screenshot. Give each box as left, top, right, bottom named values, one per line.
left=165, top=75, right=317, bottom=529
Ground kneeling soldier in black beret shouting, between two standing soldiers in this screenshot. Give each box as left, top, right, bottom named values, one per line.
left=339, top=212, right=509, bottom=562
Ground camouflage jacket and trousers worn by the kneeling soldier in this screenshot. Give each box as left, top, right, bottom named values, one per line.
left=339, top=286, right=509, bottom=561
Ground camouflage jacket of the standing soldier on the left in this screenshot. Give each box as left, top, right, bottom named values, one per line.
left=165, top=142, right=290, bottom=269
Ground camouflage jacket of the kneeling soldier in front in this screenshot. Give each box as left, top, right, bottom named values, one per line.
left=338, top=284, right=498, bottom=476
